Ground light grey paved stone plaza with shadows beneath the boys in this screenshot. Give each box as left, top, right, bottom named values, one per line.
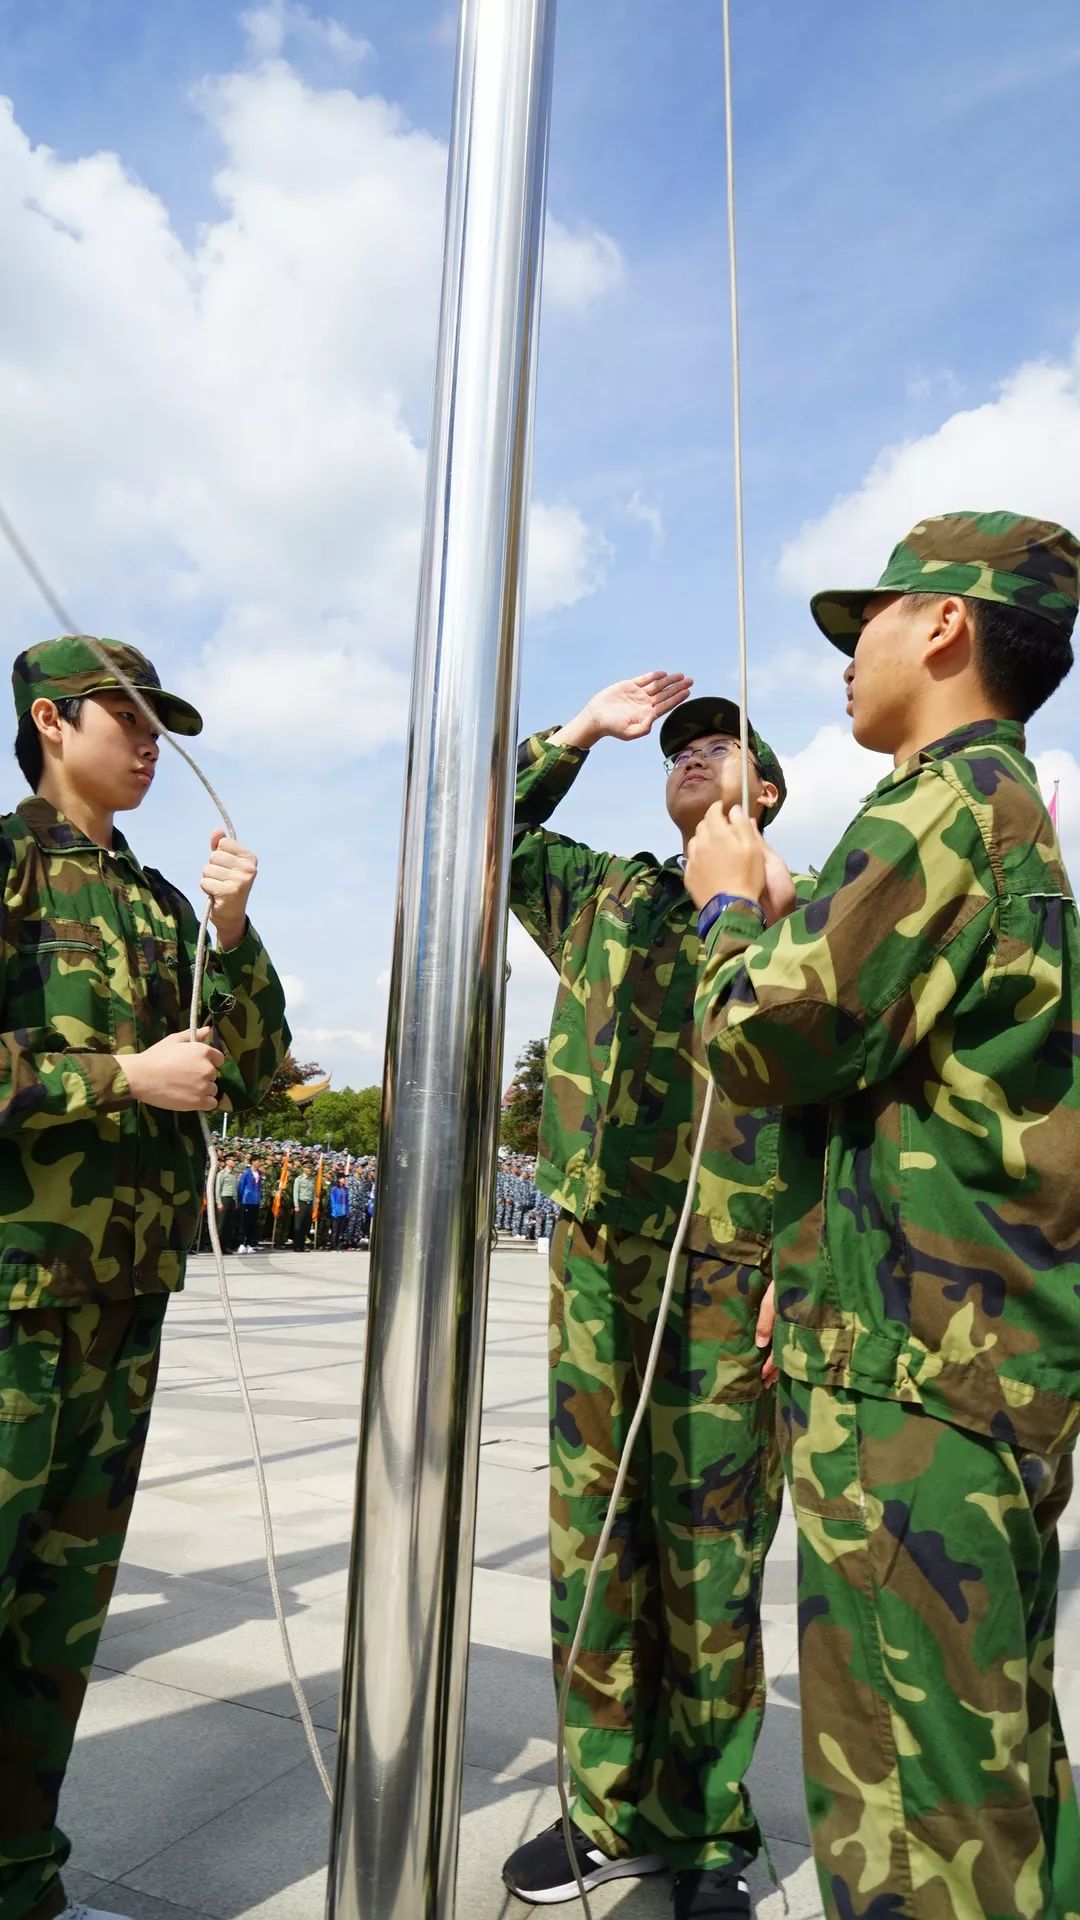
left=61, top=1246, right=1080, bottom=1920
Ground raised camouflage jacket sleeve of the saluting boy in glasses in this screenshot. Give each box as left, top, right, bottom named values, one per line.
left=509, top=730, right=615, bottom=966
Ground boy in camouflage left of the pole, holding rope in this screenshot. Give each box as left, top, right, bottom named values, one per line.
left=0, top=637, right=288, bottom=1920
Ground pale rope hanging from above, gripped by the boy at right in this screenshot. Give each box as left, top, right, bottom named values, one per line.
left=555, top=0, right=753, bottom=1920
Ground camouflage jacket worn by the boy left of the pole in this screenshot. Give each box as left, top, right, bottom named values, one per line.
left=0, top=799, right=288, bottom=1308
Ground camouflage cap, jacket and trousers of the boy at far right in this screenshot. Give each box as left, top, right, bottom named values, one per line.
left=698, top=515, right=1080, bottom=1920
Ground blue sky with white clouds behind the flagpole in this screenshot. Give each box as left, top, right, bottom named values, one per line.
left=0, top=0, right=1080, bottom=1085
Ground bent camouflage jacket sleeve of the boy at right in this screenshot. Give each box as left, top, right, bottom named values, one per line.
left=696, top=764, right=997, bottom=1106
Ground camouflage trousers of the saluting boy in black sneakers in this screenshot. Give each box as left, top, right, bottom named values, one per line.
left=550, top=1215, right=782, bottom=1868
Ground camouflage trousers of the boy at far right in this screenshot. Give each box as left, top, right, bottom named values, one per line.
left=780, top=1380, right=1080, bottom=1920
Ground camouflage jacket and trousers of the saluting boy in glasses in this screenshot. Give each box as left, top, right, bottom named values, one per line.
left=511, top=735, right=780, bottom=1868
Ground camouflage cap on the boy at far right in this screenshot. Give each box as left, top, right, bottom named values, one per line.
left=811, top=513, right=1080, bottom=655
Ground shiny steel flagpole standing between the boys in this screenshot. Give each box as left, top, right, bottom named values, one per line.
left=329, top=0, right=555, bottom=1920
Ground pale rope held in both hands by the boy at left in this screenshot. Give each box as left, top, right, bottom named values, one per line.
left=0, top=507, right=332, bottom=1799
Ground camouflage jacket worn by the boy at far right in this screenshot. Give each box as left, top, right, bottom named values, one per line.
left=698, top=720, right=1080, bottom=1452
